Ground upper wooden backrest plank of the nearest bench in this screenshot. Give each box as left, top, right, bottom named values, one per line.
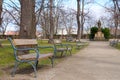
left=13, top=39, right=37, bottom=46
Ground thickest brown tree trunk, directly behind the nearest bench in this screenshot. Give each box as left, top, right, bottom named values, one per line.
left=19, top=0, right=36, bottom=38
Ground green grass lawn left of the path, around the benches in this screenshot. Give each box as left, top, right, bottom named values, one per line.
left=0, top=40, right=88, bottom=75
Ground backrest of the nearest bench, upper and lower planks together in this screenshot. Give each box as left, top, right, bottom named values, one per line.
left=8, top=38, right=37, bottom=55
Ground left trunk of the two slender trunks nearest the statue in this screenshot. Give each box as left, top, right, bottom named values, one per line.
left=76, top=0, right=81, bottom=39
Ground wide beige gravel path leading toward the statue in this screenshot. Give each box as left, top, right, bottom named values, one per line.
left=1, top=41, right=120, bottom=80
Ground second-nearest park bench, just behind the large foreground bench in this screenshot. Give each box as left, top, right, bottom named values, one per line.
left=53, top=39, right=72, bottom=56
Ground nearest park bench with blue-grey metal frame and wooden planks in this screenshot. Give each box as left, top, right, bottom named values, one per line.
left=8, top=38, right=54, bottom=77
